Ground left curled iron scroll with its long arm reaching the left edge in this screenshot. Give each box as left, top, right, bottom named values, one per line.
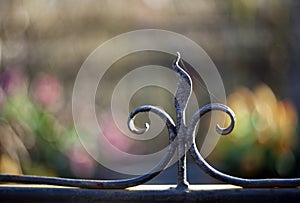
left=0, top=106, right=176, bottom=189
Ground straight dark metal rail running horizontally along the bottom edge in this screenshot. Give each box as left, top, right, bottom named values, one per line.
left=0, top=185, right=300, bottom=203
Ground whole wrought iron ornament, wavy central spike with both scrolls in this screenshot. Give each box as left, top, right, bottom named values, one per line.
left=0, top=52, right=300, bottom=189
